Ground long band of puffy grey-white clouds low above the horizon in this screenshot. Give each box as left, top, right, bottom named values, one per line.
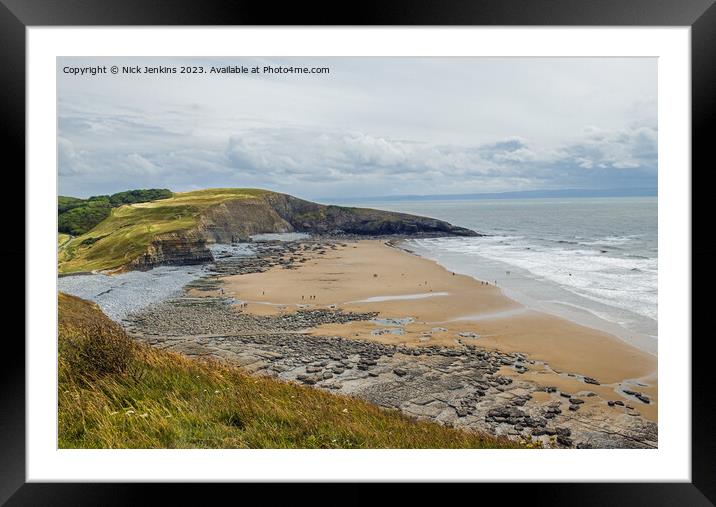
left=59, top=118, right=656, bottom=199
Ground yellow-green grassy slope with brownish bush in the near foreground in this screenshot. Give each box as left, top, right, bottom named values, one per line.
left=58, top=294, right=517, bottom=448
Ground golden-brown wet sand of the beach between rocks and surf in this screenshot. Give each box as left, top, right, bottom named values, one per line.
left=215, top=240, right=658, bottom=421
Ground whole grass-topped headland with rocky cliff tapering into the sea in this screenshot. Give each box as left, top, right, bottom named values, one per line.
left=58, top=189, right=478, bottom=273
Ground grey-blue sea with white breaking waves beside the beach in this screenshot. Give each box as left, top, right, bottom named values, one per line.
left=342, top=197, right=658, bottom=353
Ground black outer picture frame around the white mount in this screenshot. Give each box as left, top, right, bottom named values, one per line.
left=0, top=0, right=716, bottom=506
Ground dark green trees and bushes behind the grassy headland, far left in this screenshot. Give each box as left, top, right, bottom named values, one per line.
left=57, top=188, right=172, bottom=236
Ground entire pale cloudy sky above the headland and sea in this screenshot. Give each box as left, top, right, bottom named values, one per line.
left=57, top=57, right=657, bottom=199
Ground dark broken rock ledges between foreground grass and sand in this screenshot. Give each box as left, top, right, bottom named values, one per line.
left=124, top=297, right=658, bottom=449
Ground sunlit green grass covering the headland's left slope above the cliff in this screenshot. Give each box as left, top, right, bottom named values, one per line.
left=58, top=188, right=266, bottom=273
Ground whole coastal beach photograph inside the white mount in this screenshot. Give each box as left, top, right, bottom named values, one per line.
left=57, top=55, right=660, bottom=448
